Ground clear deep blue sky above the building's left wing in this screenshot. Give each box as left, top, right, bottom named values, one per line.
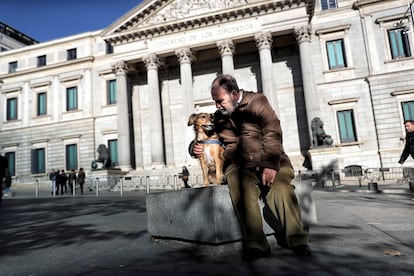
left=0, top=0, right=142, bottom=42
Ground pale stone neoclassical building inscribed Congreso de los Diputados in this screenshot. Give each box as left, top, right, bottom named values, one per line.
left=0, top=0, right=414, bottom=183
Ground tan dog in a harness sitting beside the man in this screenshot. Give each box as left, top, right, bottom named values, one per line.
left=188, top=113, right=224, bottom=186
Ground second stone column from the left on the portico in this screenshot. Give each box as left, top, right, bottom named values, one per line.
left=144, top=54, right=164, bottom=165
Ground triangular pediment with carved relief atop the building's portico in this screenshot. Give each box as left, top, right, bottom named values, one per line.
left=101, top=0, right=314, bottom=43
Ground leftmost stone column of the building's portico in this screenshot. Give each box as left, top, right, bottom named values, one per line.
left=112, top=61, right=131, bottom=170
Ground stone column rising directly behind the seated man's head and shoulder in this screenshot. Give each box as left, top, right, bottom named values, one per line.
left=254, top=33, right=279, bottom=114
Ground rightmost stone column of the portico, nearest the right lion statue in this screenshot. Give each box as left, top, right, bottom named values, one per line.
left=295, top=25, right=321, bottom=137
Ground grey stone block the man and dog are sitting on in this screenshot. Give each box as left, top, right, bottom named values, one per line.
left=146, top=184, right=316, bottom=245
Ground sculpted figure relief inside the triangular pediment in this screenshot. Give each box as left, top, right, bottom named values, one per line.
left=141, top=0, right=263, bottom=26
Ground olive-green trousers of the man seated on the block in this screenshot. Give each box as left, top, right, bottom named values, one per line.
left=226, top=167, right=308, bottom=252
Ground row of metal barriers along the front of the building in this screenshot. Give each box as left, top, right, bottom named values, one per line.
left=28, top=165, right=414, bottom=197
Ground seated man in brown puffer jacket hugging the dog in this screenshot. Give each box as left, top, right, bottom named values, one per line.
left=192, top=75, right=311, bottom=261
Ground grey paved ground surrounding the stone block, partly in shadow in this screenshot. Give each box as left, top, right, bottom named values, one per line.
left=0, top=189, right=414, bottom=276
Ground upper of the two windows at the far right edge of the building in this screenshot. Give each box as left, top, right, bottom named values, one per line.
left=388, top=28, right=411, bottom=59
